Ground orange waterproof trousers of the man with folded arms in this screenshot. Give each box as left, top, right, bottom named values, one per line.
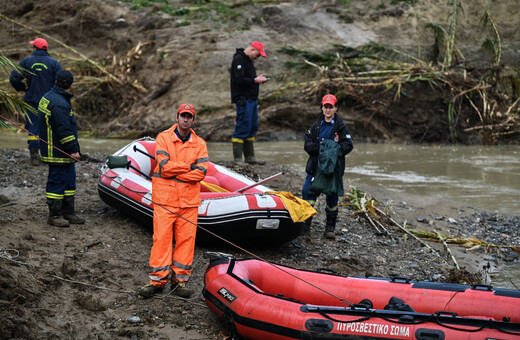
left=149, top=206, right=198, bottom=284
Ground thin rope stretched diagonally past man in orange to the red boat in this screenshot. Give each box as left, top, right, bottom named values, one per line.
left=0, top=114, right=354, bottom=308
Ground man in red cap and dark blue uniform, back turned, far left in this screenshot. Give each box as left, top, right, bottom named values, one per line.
left=9, top=38, right=61, bottom=165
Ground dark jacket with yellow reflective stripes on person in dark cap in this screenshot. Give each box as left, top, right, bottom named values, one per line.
left=38, top=85, right=80, bottom=165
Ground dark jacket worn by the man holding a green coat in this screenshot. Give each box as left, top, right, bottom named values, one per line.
left=303, top=113, right=354, bottom=176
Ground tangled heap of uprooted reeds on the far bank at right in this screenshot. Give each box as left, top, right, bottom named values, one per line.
left=271, top=0, right=520, bottom=144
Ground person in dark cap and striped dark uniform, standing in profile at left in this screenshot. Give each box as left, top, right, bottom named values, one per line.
left=38, top=71, right=85, bottom=227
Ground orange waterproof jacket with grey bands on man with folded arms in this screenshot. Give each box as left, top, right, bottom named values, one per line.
left=152, top=124, right=209, bottom=208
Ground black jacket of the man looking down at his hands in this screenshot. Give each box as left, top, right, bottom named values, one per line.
left=230, top=48, right=259, bottom=103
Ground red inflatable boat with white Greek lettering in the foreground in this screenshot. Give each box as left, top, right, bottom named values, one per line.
left=203, top=256, right=520, bottom=340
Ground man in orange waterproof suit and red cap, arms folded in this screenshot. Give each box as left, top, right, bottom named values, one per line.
left=139, top=104, right=209, bottom=297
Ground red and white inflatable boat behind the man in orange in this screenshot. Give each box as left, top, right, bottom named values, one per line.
left=98, top=137, right=301, bottom=243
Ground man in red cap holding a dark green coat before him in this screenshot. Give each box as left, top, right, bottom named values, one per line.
left=302, top=94, right=354, bottom=239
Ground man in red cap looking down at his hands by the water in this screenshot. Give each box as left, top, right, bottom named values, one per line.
left=230, top=41, right=268, bottom=165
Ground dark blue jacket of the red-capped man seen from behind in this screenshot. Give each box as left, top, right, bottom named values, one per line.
left=9, top=50, right=61, bottom=107
